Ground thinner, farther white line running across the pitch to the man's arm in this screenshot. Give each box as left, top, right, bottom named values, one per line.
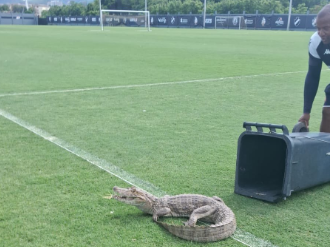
left=0, top=71, right=306, bottom=97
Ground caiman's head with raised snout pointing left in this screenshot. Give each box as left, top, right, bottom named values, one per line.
left=113, top=186, right=157, bottom=214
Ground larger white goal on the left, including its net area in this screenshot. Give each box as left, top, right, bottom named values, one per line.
left=100, top=9, right=150, bottom=31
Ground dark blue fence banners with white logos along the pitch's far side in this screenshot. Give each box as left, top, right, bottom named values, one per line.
left=46, top=14, right=316, bottom=30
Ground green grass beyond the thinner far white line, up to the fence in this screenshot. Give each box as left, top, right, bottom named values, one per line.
left=0, top=26, right=310, bottom=94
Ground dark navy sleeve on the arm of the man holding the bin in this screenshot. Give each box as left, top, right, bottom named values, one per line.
left=304, top=54, right=322, bottom=113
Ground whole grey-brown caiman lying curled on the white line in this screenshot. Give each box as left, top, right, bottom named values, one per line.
left=106, top=186, right=236, bottom=242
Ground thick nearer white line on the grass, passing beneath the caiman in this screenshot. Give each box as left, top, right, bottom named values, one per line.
left=0, top=109, right=276, bottom=247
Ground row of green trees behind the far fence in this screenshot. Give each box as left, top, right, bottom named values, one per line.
left=0, top=0, right=330, bottom=17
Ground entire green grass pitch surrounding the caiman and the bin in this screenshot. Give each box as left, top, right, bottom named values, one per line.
left=0, top=26, right=330, bottom=247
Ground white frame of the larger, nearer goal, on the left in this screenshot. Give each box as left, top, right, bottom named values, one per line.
left=100, top=9, right=150, bottom=31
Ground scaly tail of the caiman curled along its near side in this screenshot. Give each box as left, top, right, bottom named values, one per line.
left=157, top=217, right=236, bottom=242
